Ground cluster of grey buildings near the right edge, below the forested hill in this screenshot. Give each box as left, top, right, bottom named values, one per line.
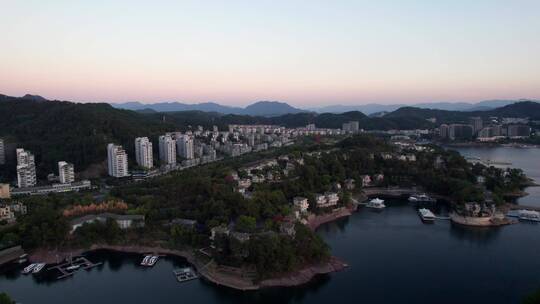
left=439, top=117, right=531, bottom=141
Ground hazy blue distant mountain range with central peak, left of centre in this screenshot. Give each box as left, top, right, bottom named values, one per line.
left=111, top=101, right=307, bottom=117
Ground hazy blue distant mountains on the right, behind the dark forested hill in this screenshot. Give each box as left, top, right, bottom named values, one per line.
left=309, top=100, right=538, bottom=115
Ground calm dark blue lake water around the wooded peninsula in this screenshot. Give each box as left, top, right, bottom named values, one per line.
left=0, top=148, right=540, bottom=304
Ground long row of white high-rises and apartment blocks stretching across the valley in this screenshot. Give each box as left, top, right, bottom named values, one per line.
left=107, top=121, right=346, bottom=179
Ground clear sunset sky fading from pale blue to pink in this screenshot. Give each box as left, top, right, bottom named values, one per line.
left=0, top=0, right=540, bottom=107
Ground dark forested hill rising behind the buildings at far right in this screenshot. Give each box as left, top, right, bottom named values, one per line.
left=384, top=101, right=540, bottom=123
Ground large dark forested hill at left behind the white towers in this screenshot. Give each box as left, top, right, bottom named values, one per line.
left=0, top=96, right=174, bottom=176
